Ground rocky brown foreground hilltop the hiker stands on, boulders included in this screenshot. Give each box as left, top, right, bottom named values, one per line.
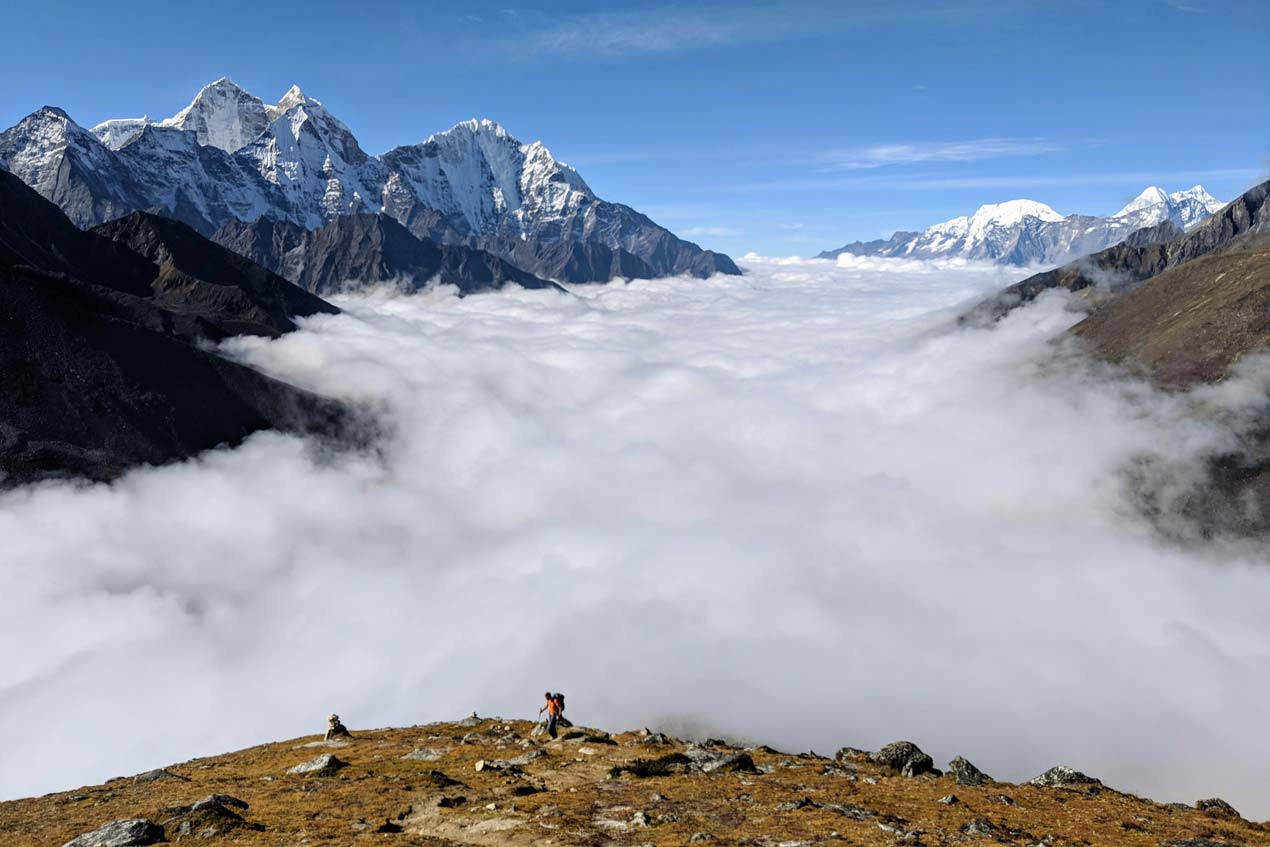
left=9, top=716, right=1270, bottom=847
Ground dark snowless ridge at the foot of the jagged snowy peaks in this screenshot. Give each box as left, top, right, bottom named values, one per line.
left=212, top=215, right=558, bottom=293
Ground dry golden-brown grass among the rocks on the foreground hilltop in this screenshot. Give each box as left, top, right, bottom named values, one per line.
left=0, top=720, right=1270, bottom=847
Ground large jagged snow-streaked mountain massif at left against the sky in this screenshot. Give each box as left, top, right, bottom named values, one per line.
left=0, top=80, right=739, bottom=282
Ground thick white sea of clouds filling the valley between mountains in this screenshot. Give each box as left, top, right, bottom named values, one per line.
left=0, top=257, right=1270, bottom=817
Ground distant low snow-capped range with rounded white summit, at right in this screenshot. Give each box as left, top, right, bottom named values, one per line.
left=819, top=185, right=1223, bottom=265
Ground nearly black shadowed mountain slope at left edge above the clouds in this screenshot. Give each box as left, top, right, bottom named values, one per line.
left=0, top=171, right=349, bottom=485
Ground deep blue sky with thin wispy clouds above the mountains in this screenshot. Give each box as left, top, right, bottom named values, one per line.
left=0, top=0, right=1270, bottom=254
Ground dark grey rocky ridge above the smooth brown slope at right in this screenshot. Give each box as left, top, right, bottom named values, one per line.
left=966, top=183, right=1270, bottom=320
